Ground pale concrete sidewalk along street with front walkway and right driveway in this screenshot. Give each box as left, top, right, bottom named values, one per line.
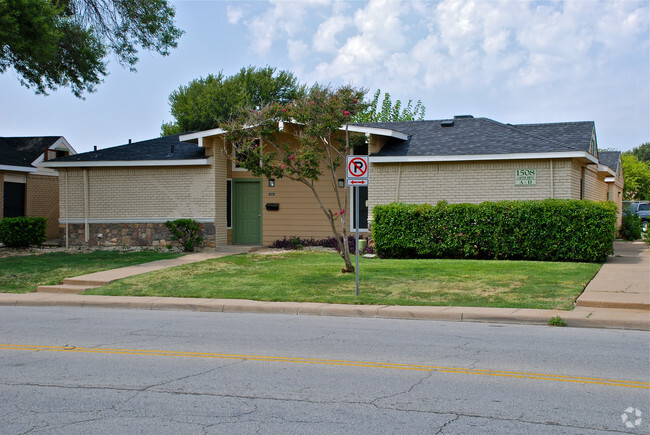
left=0, top=242, right=650, bottom=331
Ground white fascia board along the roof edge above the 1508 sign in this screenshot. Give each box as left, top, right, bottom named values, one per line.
left=370, top=151, right=598, bottom=163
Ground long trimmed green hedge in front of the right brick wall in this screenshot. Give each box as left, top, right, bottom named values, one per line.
left=372, top=199, right=617, bottom=262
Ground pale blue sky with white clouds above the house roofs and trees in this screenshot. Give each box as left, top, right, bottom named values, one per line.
left=0, top=0, right=650, bottom=152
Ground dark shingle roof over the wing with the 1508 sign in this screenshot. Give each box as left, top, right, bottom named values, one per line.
left=357, top=117, right=594, bottom=156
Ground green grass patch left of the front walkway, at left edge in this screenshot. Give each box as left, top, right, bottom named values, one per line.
left=0, top=251, right=181, bottom=293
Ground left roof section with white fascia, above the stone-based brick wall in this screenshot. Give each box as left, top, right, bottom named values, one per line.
left=43, top=134, right=208, bottom=168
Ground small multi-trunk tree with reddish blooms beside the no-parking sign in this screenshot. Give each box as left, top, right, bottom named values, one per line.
left=221, top=84, right=365, bottom=272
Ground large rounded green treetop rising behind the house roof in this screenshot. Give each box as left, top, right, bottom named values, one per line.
left=161, top=66, right=304, bottom=136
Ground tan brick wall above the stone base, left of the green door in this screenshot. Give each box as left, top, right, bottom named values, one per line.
left=60, top=166, right=215, bottom=219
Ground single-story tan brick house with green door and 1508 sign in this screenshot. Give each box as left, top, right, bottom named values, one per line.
left=45, top=116, right=622, bottom=247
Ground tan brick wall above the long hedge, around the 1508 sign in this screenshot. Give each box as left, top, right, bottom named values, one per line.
left=368, top=160, right=580, bottom=220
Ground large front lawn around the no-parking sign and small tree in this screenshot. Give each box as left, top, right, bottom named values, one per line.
left=86, top=252, right=600, bottom=310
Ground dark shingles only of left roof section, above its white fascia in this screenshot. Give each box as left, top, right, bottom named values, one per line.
left=51, top=134, right=205, bottom=162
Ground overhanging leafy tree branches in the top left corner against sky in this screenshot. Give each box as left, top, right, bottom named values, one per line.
left=0, top=0, right=183, bottom=97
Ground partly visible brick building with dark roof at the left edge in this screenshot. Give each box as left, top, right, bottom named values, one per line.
left=0, top=136, right=75, bottom=238
